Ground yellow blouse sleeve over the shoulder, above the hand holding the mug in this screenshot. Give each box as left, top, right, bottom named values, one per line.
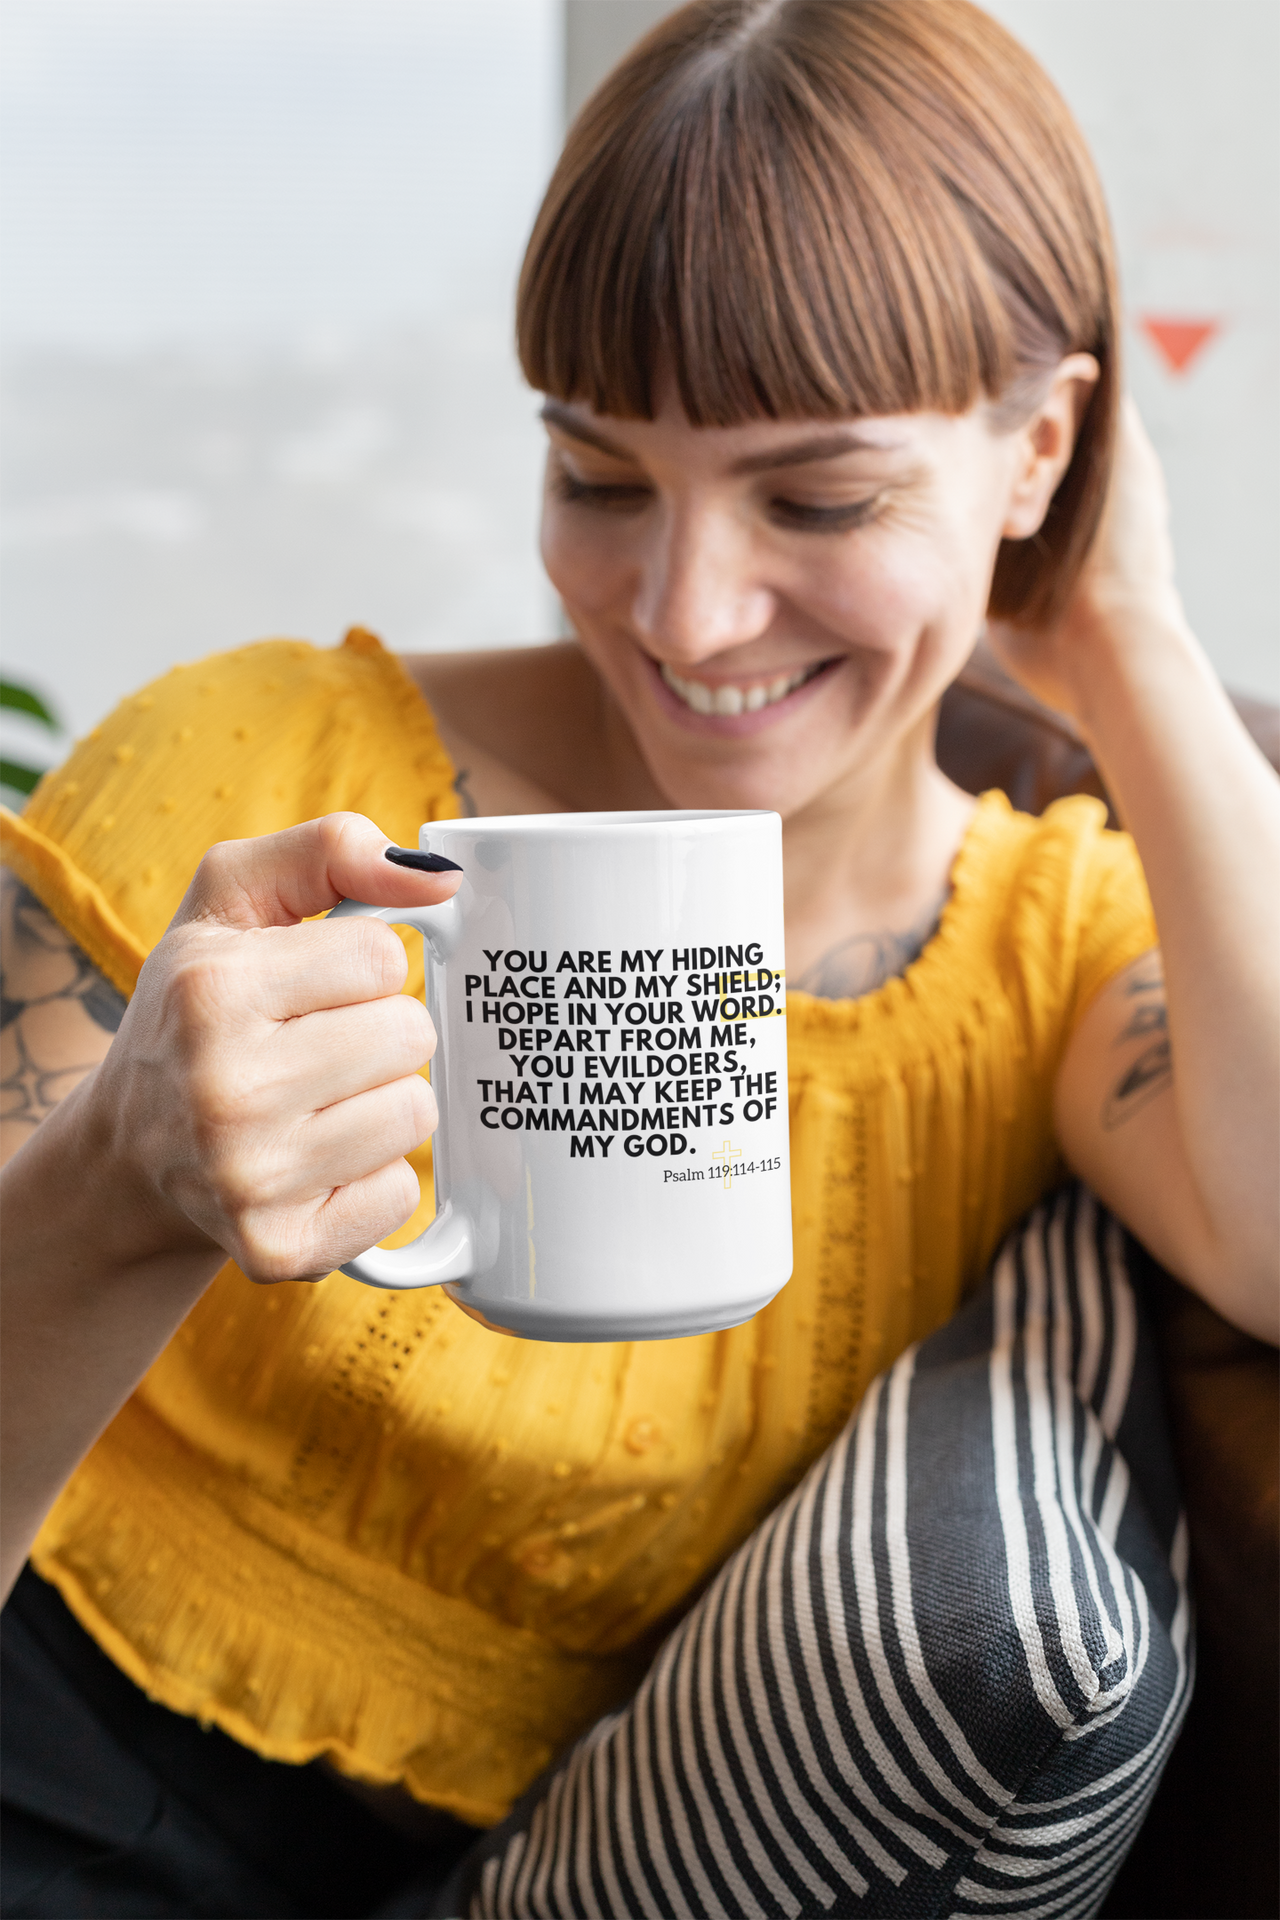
left=6, top=628, right=457, bottom=977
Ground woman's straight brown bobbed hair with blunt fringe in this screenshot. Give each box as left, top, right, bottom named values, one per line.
left=516, top=0, right=1119, bottom=622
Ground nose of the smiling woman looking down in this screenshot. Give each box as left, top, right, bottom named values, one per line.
left=631, top=507, right=775, bottom=666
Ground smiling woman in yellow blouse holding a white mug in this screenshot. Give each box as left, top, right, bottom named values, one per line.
left=4, top=0, right=1280, bottom=1912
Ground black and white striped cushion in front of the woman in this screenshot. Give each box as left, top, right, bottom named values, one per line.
left=438, top=1188, right=1190, bottom=1920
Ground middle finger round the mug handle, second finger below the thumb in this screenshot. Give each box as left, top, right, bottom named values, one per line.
left=261, top=993, right=436, bottom=1112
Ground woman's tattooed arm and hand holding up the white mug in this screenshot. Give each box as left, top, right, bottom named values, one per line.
left=0, top=814, right=457, bottom=1592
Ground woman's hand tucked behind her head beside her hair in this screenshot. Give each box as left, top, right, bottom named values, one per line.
left=986, top=399, right=1186, bottom=733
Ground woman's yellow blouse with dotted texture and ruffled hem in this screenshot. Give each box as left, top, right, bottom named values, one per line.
left=4, top=632, right=1155, bottom=1822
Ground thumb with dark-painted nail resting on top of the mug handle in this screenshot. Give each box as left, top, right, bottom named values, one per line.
left=173, top=814, right=462, bottom=927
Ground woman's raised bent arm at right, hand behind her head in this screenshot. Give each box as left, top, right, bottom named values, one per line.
left=992, top=407, right=1280, bottom=1340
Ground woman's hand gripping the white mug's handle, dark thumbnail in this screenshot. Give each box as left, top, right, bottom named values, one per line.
left=86, top=814, right=457, bottom=1281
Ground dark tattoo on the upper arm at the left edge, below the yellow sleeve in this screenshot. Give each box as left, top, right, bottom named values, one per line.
left=0, top=872, right=125, bottom=1150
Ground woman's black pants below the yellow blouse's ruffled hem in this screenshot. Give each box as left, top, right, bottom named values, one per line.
left=0, top=1569, right=476, bottom=1920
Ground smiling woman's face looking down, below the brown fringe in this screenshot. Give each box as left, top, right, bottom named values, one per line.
left=541, top=382, right=1048, bottom=816
